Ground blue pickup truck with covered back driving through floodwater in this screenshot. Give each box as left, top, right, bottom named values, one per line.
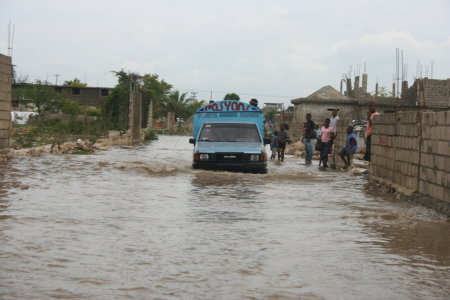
left=189, top=100, right=270, bottom=173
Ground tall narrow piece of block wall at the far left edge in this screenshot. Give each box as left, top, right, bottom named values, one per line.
left=0, top=54, right=12, bottom=151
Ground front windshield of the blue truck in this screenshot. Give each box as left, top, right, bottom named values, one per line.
left=199, top=123, right=261, bottom=143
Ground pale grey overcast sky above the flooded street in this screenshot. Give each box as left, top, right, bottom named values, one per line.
left=0, top=0, right=450, bottom=104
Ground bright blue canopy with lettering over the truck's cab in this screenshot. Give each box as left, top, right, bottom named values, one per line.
left=193, top=100, right=264, bottom=139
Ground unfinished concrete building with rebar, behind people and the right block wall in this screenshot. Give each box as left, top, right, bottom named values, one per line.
left=291, top=74, right=450, bottom=127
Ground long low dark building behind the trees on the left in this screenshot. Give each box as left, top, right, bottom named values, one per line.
left=12, top=84, right=112, bottom=110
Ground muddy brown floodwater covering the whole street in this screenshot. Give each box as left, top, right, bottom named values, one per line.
left=0, top=137, right=450, bottom=299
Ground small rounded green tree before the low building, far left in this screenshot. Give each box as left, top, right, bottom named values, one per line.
left=19, top=80, right=63, bottom=118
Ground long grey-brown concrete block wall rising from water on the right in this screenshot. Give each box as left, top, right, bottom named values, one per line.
left=370, top=111, right=450, bottom=216
